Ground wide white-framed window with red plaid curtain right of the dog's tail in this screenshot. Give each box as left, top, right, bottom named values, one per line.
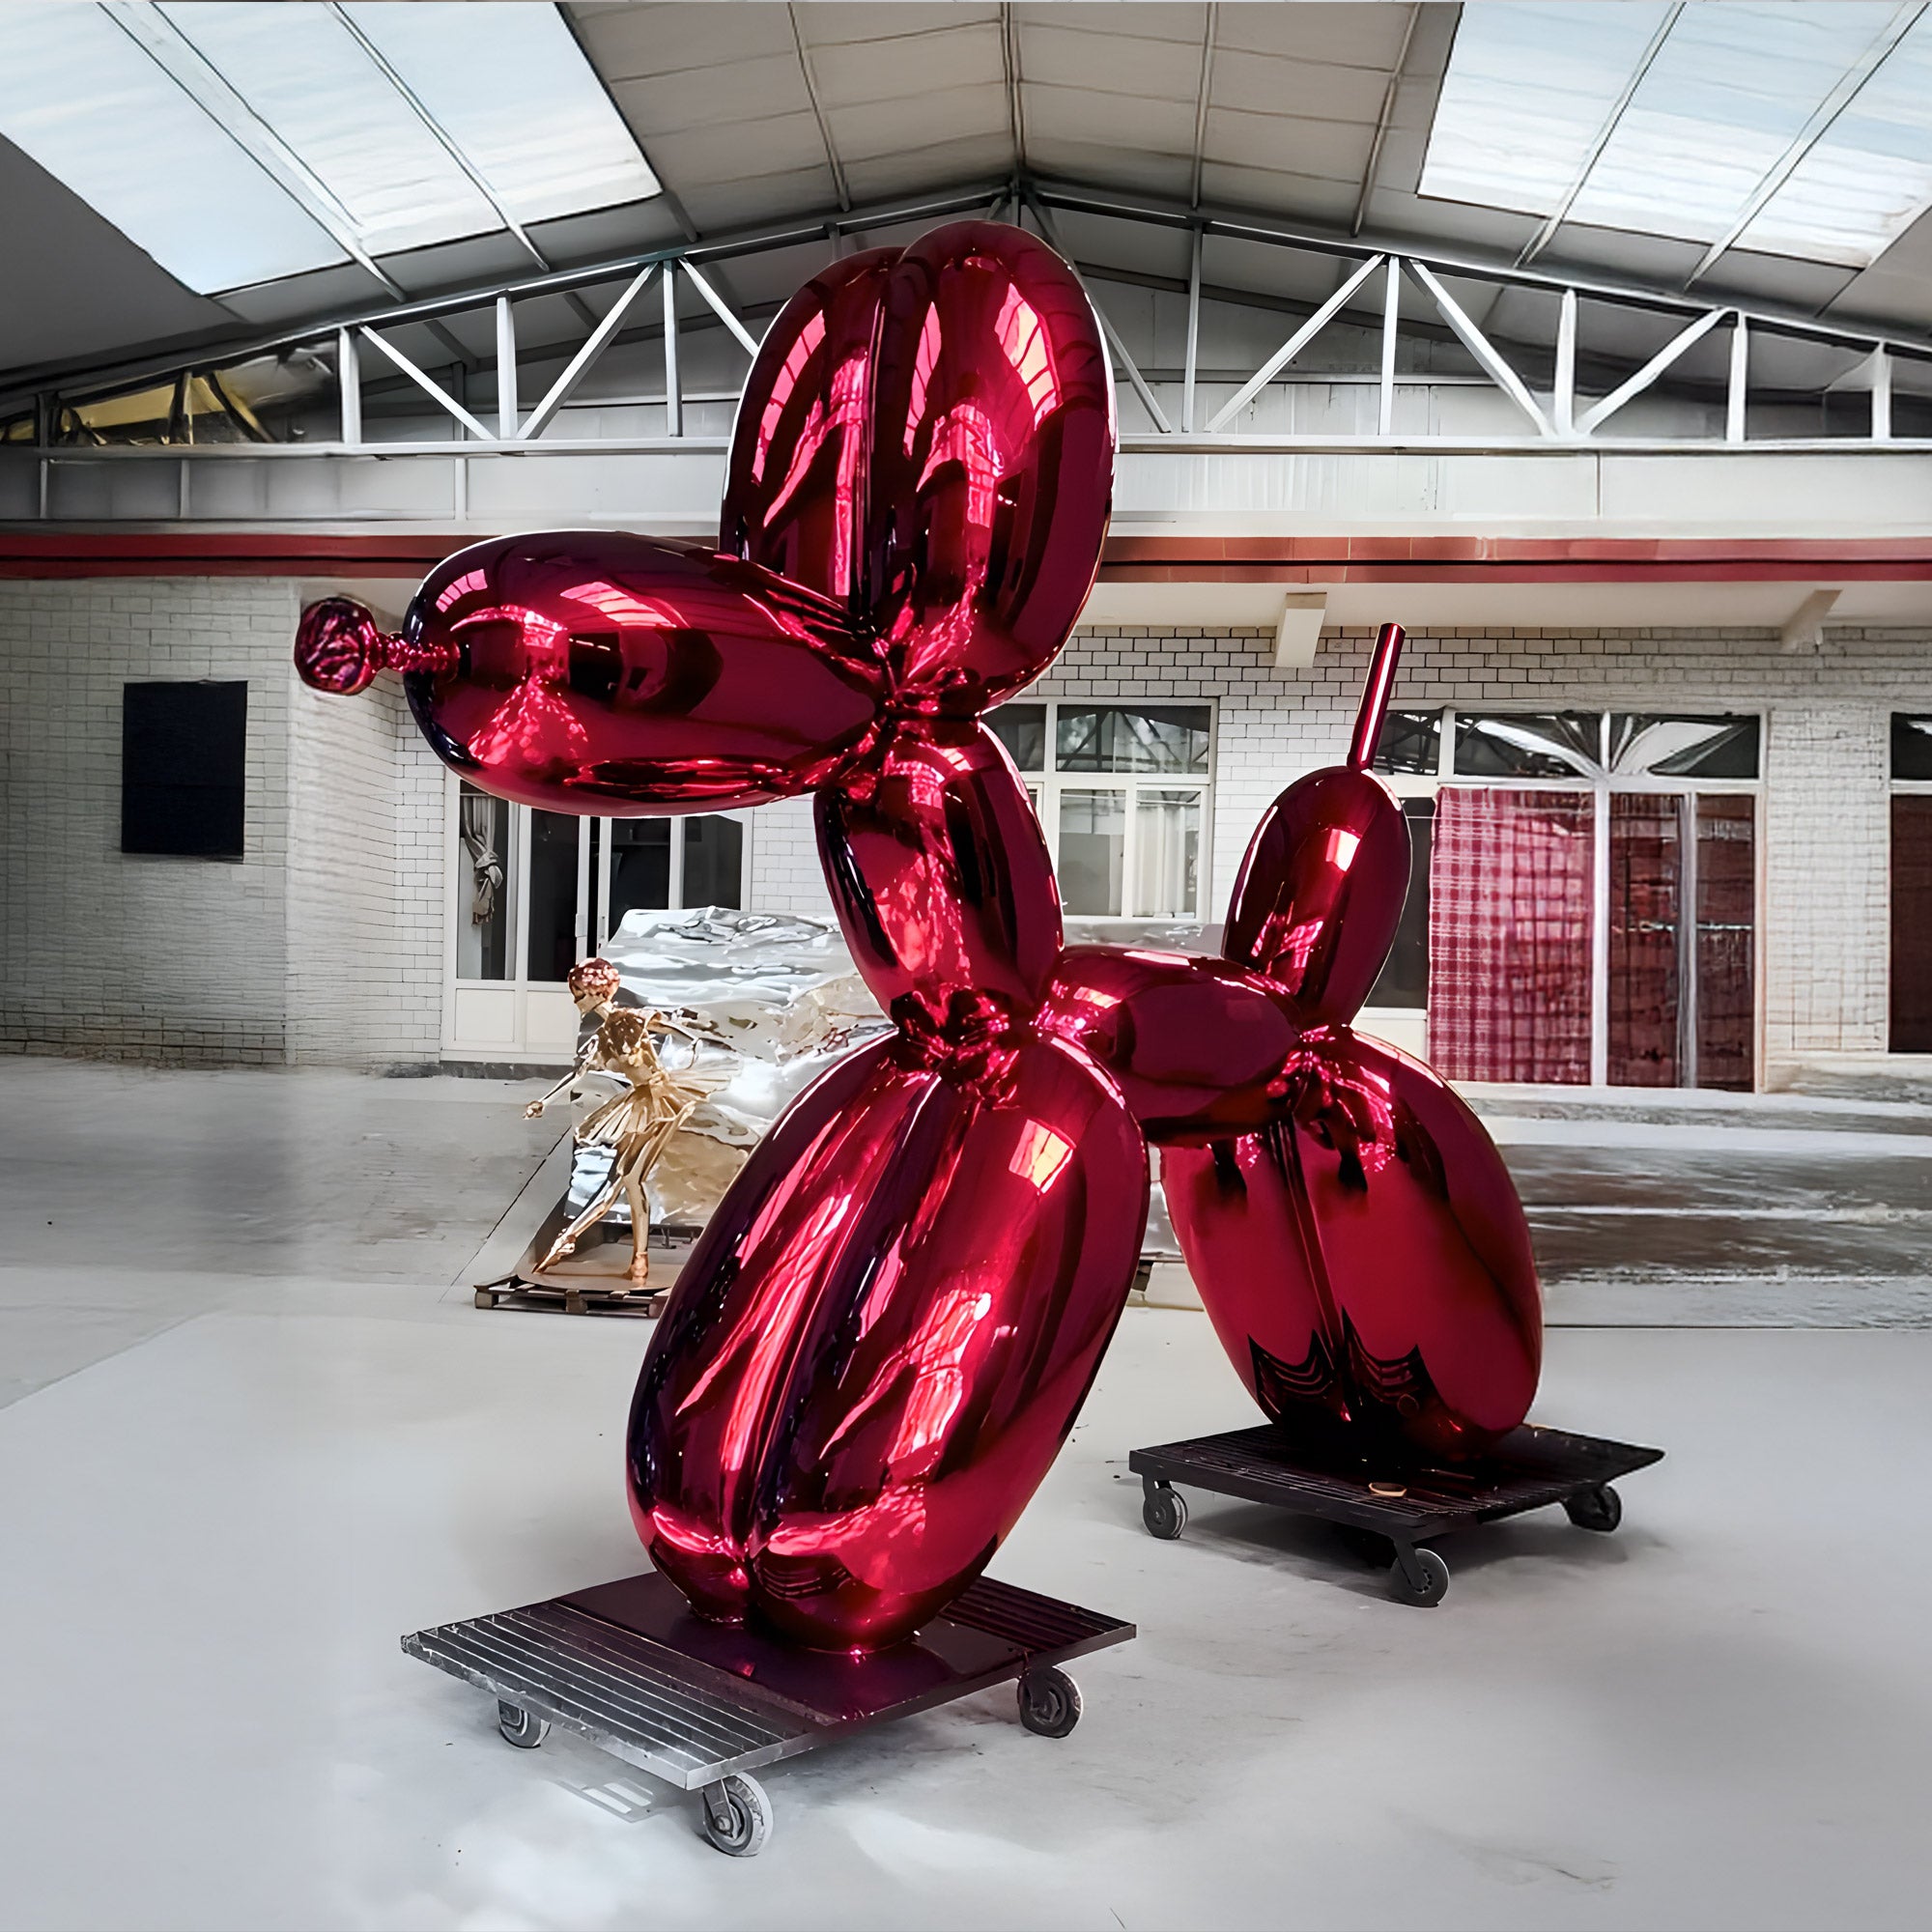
left=1368, top=709, right=1762, bottom=1088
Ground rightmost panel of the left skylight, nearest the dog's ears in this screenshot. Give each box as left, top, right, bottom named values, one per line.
left=344, top=0, right=661, bottom=222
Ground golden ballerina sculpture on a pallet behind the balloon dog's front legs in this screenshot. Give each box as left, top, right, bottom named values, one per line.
left=524, top=960, right=705, bottom=1287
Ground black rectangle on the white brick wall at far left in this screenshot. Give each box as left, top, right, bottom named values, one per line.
left=122, top=682, right=247, bottom=858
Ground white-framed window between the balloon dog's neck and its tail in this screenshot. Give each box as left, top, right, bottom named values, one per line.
left=987, top=699, right=1213, bottom=920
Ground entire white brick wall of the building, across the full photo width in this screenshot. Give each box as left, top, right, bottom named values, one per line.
left=0, top=578, right=1932, bottom=1065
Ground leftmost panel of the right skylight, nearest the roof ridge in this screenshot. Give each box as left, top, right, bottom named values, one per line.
left=1422, top=0, right=1669, bottom=214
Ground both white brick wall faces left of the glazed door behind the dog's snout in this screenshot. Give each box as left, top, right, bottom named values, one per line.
left=0, top=578, right=442, bottom=1065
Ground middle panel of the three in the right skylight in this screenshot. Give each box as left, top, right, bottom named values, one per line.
left=1571, top=0, right=1897, bottom=242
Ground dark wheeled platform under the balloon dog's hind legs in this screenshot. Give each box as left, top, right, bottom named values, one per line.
left=1126, top=1422, right=1663, bottom=1605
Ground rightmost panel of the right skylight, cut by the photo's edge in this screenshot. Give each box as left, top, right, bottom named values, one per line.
left=1737, top=19, right=1932, bottom=269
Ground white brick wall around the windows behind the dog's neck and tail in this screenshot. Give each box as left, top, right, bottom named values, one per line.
left=738, top=628, right=1932, bottom=1063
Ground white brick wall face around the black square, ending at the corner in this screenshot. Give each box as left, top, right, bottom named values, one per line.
left=0, top=578, right=294, bottom=1063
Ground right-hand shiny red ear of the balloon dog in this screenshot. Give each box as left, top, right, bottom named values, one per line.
left=864, top=222, right=1113, bottom=715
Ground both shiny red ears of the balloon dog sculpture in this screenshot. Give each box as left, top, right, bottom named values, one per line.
left=719, top=222, right=1113, bottom=717
